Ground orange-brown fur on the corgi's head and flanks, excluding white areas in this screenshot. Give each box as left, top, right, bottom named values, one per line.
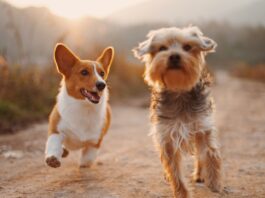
left=48, top=44, right=113, bottom=139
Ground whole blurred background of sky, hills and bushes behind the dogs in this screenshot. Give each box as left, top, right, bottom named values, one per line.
left=0, top=0, right=265, bottom=133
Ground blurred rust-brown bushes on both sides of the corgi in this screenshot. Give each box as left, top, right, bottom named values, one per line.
left=0, top=52, right=146, bottom=134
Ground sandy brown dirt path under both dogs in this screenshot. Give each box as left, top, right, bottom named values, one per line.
left=0, top=73, right=265, bottom=198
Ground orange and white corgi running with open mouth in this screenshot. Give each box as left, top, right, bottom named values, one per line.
left=45, top=44, right=114, bottom=168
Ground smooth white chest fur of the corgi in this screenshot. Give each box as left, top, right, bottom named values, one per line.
left=58, top=86, right=107, bottom=149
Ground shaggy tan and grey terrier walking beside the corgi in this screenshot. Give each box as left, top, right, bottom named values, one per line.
left=133, top=26, right=222, bottom=198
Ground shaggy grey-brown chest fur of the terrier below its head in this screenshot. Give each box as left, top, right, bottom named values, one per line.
left=151, top=73, right=214, bottom=146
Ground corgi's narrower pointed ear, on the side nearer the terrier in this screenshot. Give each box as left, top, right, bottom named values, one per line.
left=97, top=47, right=114, bottom=75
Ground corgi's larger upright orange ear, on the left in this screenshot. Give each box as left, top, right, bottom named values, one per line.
left=54, top=43, right=79, bottom=78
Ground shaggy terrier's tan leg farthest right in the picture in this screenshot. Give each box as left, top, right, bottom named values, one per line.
left=194, top=130, right=222, bottom=192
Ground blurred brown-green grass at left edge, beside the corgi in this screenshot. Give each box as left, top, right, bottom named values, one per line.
left=0, top=66, right=60, bottom=134
